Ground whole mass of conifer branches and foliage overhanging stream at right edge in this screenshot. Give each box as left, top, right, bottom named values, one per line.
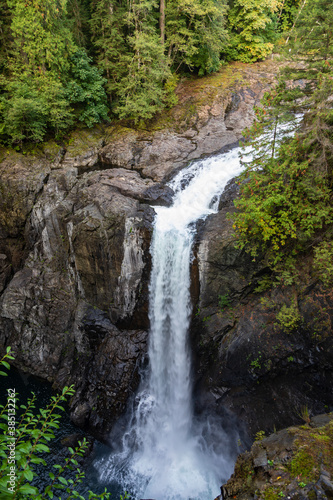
left=230, top=56, right=333, bottom=285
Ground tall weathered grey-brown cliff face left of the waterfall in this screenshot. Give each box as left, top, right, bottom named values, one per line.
left=0, top=159, right=153, bottom=439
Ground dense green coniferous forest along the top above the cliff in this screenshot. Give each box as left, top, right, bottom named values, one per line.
left=0, top=0, right=303, bottom=145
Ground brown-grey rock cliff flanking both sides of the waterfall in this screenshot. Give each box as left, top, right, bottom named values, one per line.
left=0, top=58, right=332, bottom=439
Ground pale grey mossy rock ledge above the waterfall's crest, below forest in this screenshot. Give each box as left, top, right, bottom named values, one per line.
left=99, top=63, right=276, bottom=182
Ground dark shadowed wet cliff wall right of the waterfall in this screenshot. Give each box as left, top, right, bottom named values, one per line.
left=191, top=177, right=333, bottom=435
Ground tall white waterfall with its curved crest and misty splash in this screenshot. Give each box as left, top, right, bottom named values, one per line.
left=95, top=148, right=246, bottom=500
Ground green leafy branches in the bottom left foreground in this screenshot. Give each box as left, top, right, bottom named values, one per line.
left=0, top=348, right=114, bottom=500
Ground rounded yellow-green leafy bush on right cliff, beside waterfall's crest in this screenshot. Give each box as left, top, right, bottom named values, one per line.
left=234, top=133, right=333, bottom=263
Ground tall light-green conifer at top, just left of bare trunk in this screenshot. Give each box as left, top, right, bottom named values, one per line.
left=92, top=0, right=171, bottom=122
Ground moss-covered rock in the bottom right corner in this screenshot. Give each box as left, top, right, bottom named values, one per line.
left=222, top=413, right=333, bottom=500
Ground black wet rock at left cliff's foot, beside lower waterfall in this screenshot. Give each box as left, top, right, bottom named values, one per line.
left=71, top=308, right=147, bottom=440
